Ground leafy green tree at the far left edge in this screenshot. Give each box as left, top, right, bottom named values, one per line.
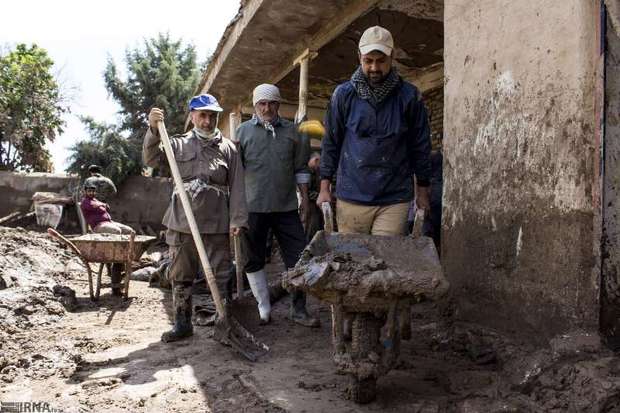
left=0, top=44, right=68, bottom=172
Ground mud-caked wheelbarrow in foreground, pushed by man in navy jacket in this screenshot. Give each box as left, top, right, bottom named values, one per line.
left=283, top=205, right=449, bottom=403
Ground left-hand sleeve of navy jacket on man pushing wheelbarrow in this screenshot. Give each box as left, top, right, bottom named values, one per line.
left=320, top=87, right=344, bottom=180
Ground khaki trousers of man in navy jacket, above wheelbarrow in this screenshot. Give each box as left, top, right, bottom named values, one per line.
left=336, top=199, right=409, bottom=235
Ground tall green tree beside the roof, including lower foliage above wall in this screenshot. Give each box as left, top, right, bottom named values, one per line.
left=68, top=34, right=200, bottom=184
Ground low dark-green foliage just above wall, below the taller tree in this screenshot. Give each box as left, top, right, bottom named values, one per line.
left=67, top=117, right=142, bottom=183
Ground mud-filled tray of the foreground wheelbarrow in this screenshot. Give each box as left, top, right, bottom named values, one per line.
left=284, top=231, right=449, bottom=312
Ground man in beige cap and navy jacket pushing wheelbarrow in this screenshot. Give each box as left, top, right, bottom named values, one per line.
left=317, top=26, right=431, bottom=235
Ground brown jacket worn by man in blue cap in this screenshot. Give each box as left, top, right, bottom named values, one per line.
left=142, top=128, right=248, bottom=234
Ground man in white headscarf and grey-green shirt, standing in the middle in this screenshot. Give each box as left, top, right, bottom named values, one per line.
left=237, top=84, right=319, bottom=327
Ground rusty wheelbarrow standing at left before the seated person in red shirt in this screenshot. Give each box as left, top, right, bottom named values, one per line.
left=47, top=228, right=156, bottom=301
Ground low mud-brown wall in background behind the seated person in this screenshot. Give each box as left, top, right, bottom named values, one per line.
left=0, top=172, right=172, bottom=230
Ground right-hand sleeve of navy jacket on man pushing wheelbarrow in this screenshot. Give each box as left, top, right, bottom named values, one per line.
left=407, top=92, right=431, bottom=186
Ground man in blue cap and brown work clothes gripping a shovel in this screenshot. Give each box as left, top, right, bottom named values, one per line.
left=142, top=94, right=248, bottom=342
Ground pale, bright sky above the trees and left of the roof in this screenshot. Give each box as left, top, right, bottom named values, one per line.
left=0, top=0, right=239, bottom=172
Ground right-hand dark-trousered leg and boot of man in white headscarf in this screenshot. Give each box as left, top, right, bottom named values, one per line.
left=271, top=210, right=319, bottom=327
